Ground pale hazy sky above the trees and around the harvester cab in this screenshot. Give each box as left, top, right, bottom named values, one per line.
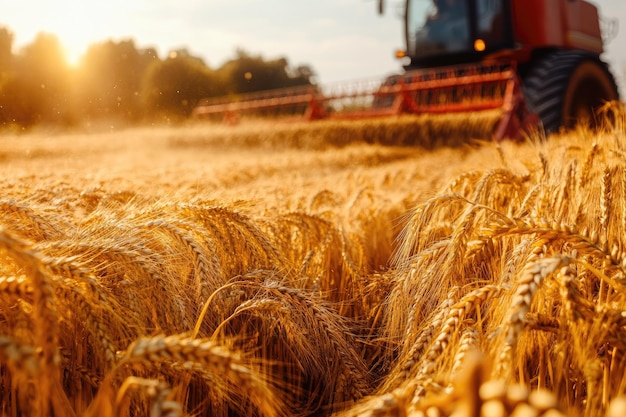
left=0, top=0, right=626, bottom=90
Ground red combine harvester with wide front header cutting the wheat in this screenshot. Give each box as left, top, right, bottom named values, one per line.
left=194, top=0, right=619, bottom=140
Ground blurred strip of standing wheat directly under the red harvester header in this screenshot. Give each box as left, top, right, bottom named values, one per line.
left=171, top=110, right=501, bottom=150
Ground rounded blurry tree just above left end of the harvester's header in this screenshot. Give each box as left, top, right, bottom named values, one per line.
left=142, top=49, right=226, bottom=118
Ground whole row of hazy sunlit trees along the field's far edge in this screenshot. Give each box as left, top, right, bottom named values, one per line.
left=0, top=27, right=315, bottom=128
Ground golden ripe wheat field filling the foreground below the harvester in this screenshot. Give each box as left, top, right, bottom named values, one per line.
left=0, top=109, right=626, bottom=417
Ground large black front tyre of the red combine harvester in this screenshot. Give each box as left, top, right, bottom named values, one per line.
left=523, top=51, right=619, bottom=134
